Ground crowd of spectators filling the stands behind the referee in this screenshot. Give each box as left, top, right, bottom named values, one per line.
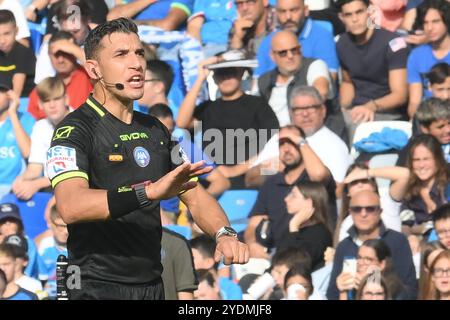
left=0, top=0, right=450, bottom=300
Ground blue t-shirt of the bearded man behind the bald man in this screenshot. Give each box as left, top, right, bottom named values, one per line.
left=254, top=18, right=339, bottom=77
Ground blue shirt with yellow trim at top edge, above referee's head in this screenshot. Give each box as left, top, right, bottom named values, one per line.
left=124, top=0, right=194, bottom=20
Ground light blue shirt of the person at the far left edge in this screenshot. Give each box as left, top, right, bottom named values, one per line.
left=0, top=112, right=35, bottom=184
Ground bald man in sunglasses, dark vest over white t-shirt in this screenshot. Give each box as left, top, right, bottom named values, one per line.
left=258, top=30, right=334, bottom=127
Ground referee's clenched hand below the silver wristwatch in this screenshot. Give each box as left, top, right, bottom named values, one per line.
left=214, top=236, right=250, bottom=265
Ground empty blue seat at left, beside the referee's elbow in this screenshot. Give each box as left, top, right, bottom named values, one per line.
left=0, top=192, right=52, bottom=239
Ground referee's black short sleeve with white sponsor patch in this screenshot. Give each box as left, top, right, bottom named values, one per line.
left=47, top=118, right=92, bottom=188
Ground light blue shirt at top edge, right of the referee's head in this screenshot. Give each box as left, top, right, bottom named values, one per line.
left=193, top=0, right=237, bottom=44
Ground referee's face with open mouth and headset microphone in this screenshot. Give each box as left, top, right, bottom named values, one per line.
left=97, top=32, right=146, bottom=100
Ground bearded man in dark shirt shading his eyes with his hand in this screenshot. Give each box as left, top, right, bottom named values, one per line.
left=245, top=125, right=336, bottom=258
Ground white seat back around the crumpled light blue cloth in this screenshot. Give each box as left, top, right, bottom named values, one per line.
left=350, top=121, right=412, bottom=159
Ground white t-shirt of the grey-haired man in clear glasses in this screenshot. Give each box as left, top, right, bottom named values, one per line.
left=252, top=126, right=352, bottom=182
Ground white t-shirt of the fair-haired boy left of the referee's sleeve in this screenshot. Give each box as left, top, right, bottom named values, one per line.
left=28, top=119, right=55, bottom=177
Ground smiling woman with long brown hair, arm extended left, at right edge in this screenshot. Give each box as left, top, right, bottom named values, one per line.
left=347, top=135, right=449, bottom=236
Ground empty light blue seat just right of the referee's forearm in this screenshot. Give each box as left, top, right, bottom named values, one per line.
left=219, top=190, right=258, bottom=233
